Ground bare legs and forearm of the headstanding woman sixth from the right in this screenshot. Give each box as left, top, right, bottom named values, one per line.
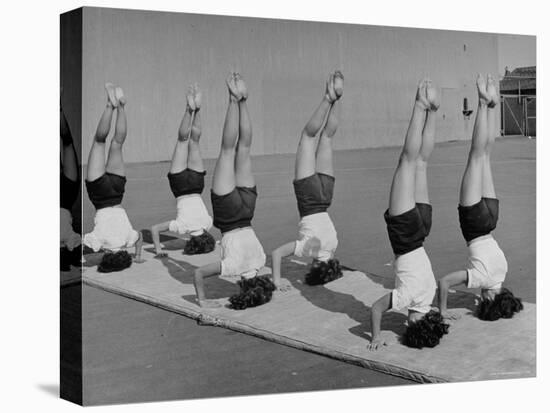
left=86, top=83, right=143, bottom=263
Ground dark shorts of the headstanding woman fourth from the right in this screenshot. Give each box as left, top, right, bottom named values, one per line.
left=211, top=186, right=258, bottom=233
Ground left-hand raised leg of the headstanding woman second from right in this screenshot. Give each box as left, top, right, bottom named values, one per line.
left=389, top=80, right=429, bottom=216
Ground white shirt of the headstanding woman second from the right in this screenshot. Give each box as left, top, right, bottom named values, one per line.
left=392, top=247, right=436, bottom=313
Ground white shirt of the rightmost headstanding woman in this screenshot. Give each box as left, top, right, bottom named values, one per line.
left=466, top=237, right=508, bottom=289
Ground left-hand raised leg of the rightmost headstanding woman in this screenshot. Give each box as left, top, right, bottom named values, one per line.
left=460, top=75, right=490, bottom=206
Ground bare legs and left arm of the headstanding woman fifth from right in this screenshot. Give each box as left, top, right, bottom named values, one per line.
left=151, top=84, right=204, bottom=258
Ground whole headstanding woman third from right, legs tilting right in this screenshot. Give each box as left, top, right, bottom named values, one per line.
left=271, top=70, right=344, bottom=291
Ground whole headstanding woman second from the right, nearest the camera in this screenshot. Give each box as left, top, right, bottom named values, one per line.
left=368, top=79, right=448, bottom=351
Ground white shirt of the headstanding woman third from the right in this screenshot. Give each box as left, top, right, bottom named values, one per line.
left=294, top=212, right=338, bottom=261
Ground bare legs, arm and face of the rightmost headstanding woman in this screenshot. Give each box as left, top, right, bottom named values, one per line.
left=439, top=75, right=500, bottom=320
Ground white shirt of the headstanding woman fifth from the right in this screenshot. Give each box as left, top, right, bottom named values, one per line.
left=168, top=194, right=212, bottom=235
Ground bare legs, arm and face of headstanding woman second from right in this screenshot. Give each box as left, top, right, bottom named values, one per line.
left=367, top=79, right=439, bottom=350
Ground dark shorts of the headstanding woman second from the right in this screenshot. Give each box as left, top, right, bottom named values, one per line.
left=384, top=203, right=432, bottom=255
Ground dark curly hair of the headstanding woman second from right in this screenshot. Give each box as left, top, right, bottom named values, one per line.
left=402, top=310, right=449, bottom=348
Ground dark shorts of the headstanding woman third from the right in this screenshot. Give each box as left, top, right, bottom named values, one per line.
left=294, top=172, right=335, bottom=218
